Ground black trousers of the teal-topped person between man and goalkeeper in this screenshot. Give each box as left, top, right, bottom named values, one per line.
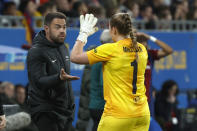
left=90, top=109, right=103, bottom=131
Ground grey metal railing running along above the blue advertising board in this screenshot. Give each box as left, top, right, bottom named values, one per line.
left=0, top=15, right=197, bottom=31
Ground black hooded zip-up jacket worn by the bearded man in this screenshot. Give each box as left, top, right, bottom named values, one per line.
left=27, top=30, right=74, bottom=120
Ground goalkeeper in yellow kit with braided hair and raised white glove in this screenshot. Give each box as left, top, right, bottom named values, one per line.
left=71, top=13, right=150, bottom=131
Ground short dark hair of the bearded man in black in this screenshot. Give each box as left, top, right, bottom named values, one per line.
left=44, top=12, right=66, bottom=26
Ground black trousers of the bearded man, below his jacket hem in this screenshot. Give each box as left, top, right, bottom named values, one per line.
left=32, top=113, right=72, bottom=131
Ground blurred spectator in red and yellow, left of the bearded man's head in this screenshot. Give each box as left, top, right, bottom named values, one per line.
left=19, top=0, right=42, bottom=45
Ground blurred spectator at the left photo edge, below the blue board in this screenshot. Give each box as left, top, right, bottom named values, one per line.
left=0, top=82, right=16, bottom=104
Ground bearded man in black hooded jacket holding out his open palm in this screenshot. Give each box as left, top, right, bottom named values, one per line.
left=27, top=12, right=79, bottom=131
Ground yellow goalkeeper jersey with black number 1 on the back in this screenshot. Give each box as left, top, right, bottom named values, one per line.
left=87, top=38, right=150, bottom=118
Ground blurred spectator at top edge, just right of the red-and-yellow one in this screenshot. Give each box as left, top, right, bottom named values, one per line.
left=38, top=1, right=57, bottom=16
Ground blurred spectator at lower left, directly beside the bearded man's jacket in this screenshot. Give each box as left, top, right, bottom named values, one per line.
left=15, top=84, right=26, bottom=106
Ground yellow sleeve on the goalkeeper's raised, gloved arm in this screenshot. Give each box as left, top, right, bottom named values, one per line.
left=87, top=43, right=115, bottom=64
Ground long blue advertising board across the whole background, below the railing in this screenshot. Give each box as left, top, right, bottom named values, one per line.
left=0, top=29, right=197, bottom=91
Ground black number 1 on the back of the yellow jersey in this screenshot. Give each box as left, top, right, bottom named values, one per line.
left=131, top=60, right=137, bottom=94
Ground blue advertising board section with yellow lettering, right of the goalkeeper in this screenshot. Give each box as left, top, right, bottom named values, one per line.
left=149, top=32, right=197, bottom=90
